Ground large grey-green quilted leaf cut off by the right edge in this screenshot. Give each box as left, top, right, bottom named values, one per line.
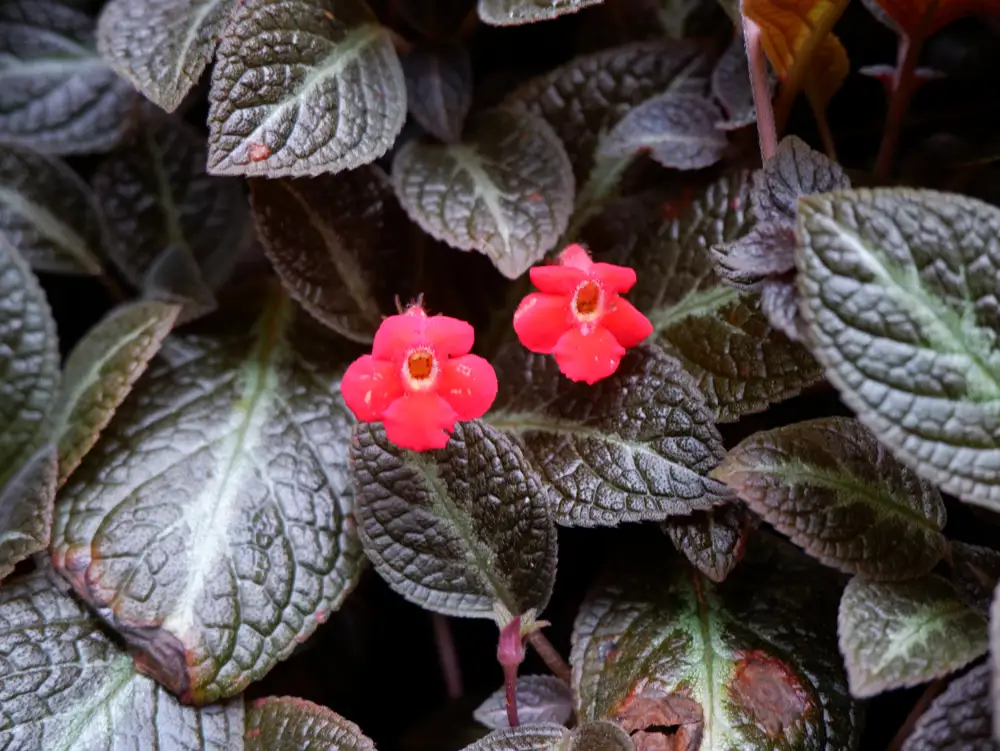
left=797, top=188, right=1000, bottom=509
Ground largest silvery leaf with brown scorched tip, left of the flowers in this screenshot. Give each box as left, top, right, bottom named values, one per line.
left=47, top=290, right=362, bottom=703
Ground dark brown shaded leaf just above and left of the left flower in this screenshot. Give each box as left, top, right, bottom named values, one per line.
left=251, top=165, right=417, bottom=342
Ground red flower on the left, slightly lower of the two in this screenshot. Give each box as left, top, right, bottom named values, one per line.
left=340, top=305, right=497, bottom=451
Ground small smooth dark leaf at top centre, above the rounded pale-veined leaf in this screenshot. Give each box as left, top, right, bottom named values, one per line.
left=403, top=43, right=472, bottom=143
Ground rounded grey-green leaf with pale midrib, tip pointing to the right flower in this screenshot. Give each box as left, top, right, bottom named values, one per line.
left=392, top=108, right=575, bottom=279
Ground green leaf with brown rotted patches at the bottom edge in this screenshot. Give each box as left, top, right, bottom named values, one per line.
left=570, top=546, right=860, bottom=751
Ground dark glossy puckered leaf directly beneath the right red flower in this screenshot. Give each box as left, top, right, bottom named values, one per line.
left=484, top=344, right=732, bottom=527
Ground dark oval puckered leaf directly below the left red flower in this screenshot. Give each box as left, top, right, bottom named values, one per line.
left=351, top=421, right=556, bottom=618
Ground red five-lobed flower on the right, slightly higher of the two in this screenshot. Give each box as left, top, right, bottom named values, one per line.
left=514, top=245, right=653, bottom=384
